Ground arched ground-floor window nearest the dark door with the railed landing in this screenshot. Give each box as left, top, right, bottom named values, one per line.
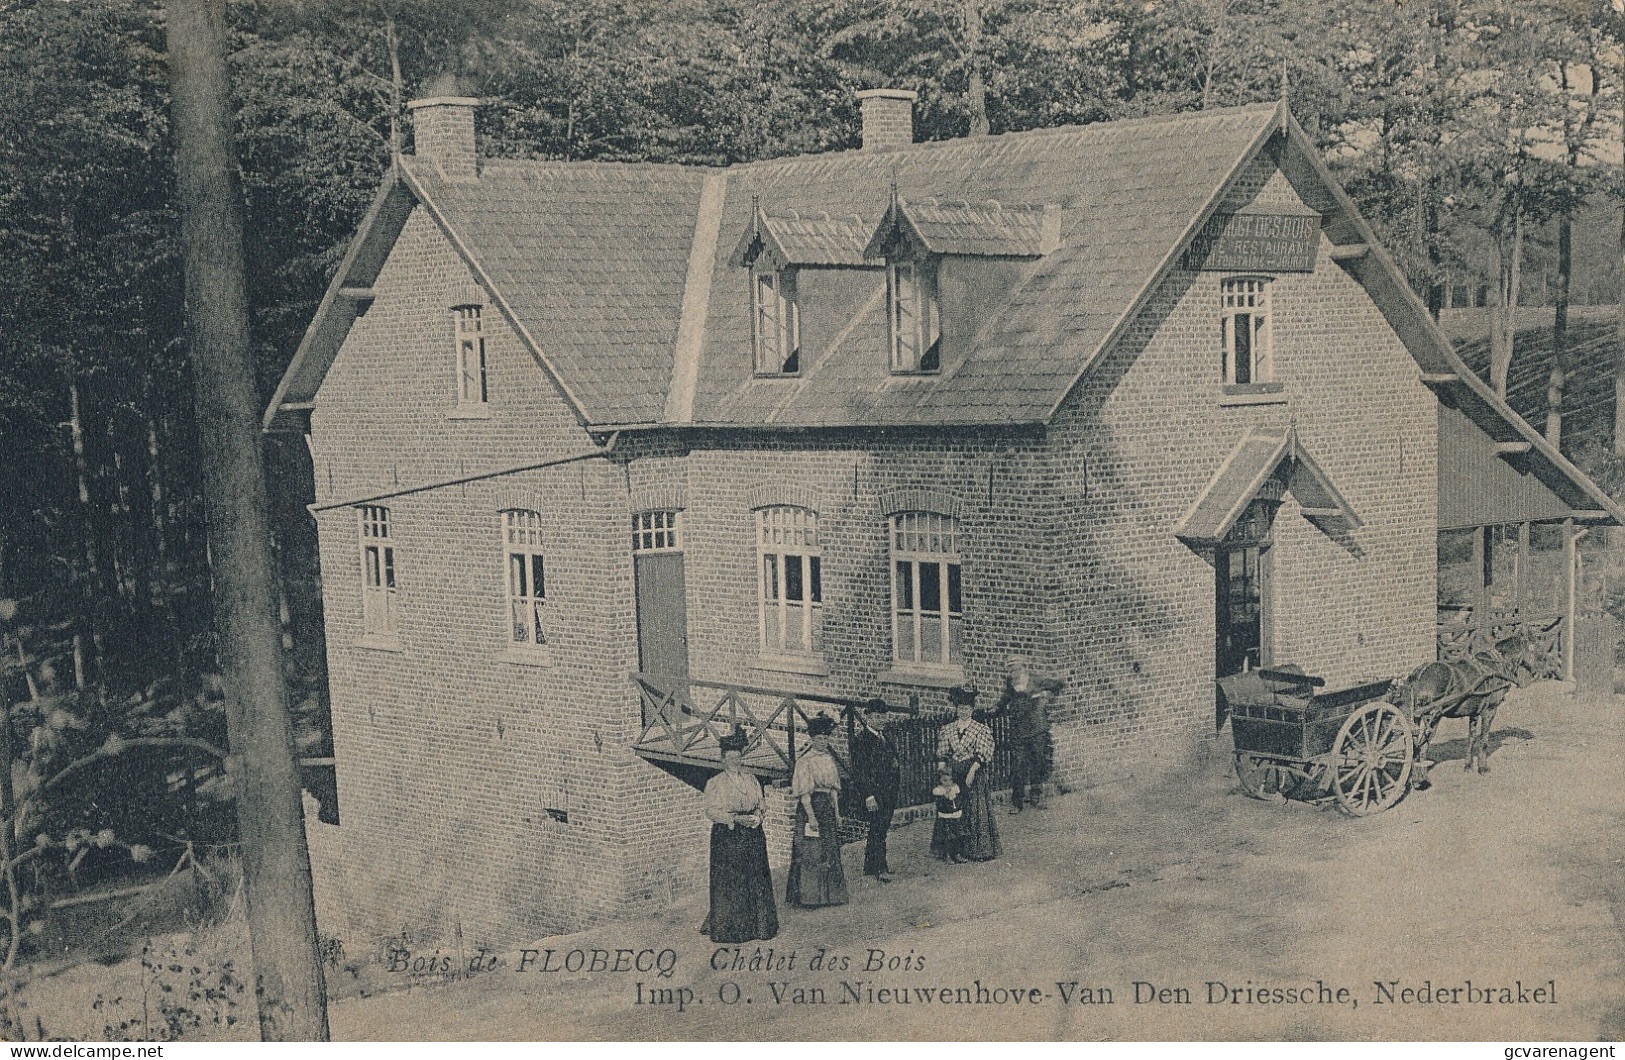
left=756, top=504, right=824, bottom=655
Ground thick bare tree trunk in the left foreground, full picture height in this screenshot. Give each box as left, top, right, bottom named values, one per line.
left=166, top=0, right=328, bottom=1040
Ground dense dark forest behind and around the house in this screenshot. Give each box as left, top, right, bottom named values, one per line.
left=0, top=0, right=1625, bottom=967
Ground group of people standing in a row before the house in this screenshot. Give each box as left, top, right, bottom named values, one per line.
left=702, top=655, right=1063, bottom=943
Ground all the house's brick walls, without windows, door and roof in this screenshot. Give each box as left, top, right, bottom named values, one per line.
left=302, top=155, right=1435, bottom=946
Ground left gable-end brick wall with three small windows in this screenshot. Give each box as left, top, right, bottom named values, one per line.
left=312, top=203, right=704, bottom=946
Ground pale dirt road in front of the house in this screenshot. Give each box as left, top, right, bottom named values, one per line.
left=332, top=686, right=1625, bottom=1040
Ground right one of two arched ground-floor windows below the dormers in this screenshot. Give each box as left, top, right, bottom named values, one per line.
left=892, top=512, right=965, bottom=665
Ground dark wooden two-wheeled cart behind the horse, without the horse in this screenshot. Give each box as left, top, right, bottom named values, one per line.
left=1219, top=668, right=1415, bottom=816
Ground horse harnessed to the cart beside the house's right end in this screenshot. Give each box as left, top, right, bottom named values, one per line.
left=1388, top=632, right=1537, bottom=788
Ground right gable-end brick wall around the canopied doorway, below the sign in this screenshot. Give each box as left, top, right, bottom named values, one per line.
left=1048, top=152, right=1437, bottom=784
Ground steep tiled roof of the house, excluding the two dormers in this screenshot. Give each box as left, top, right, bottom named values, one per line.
left=265, top=104, right=1625, bottom=519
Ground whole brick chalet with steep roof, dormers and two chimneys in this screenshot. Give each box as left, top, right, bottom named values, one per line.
left=267, top=89, right=1619, bottom=945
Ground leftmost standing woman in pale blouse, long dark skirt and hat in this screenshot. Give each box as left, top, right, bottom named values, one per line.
left=705, top=728, right=778, bottom=943
